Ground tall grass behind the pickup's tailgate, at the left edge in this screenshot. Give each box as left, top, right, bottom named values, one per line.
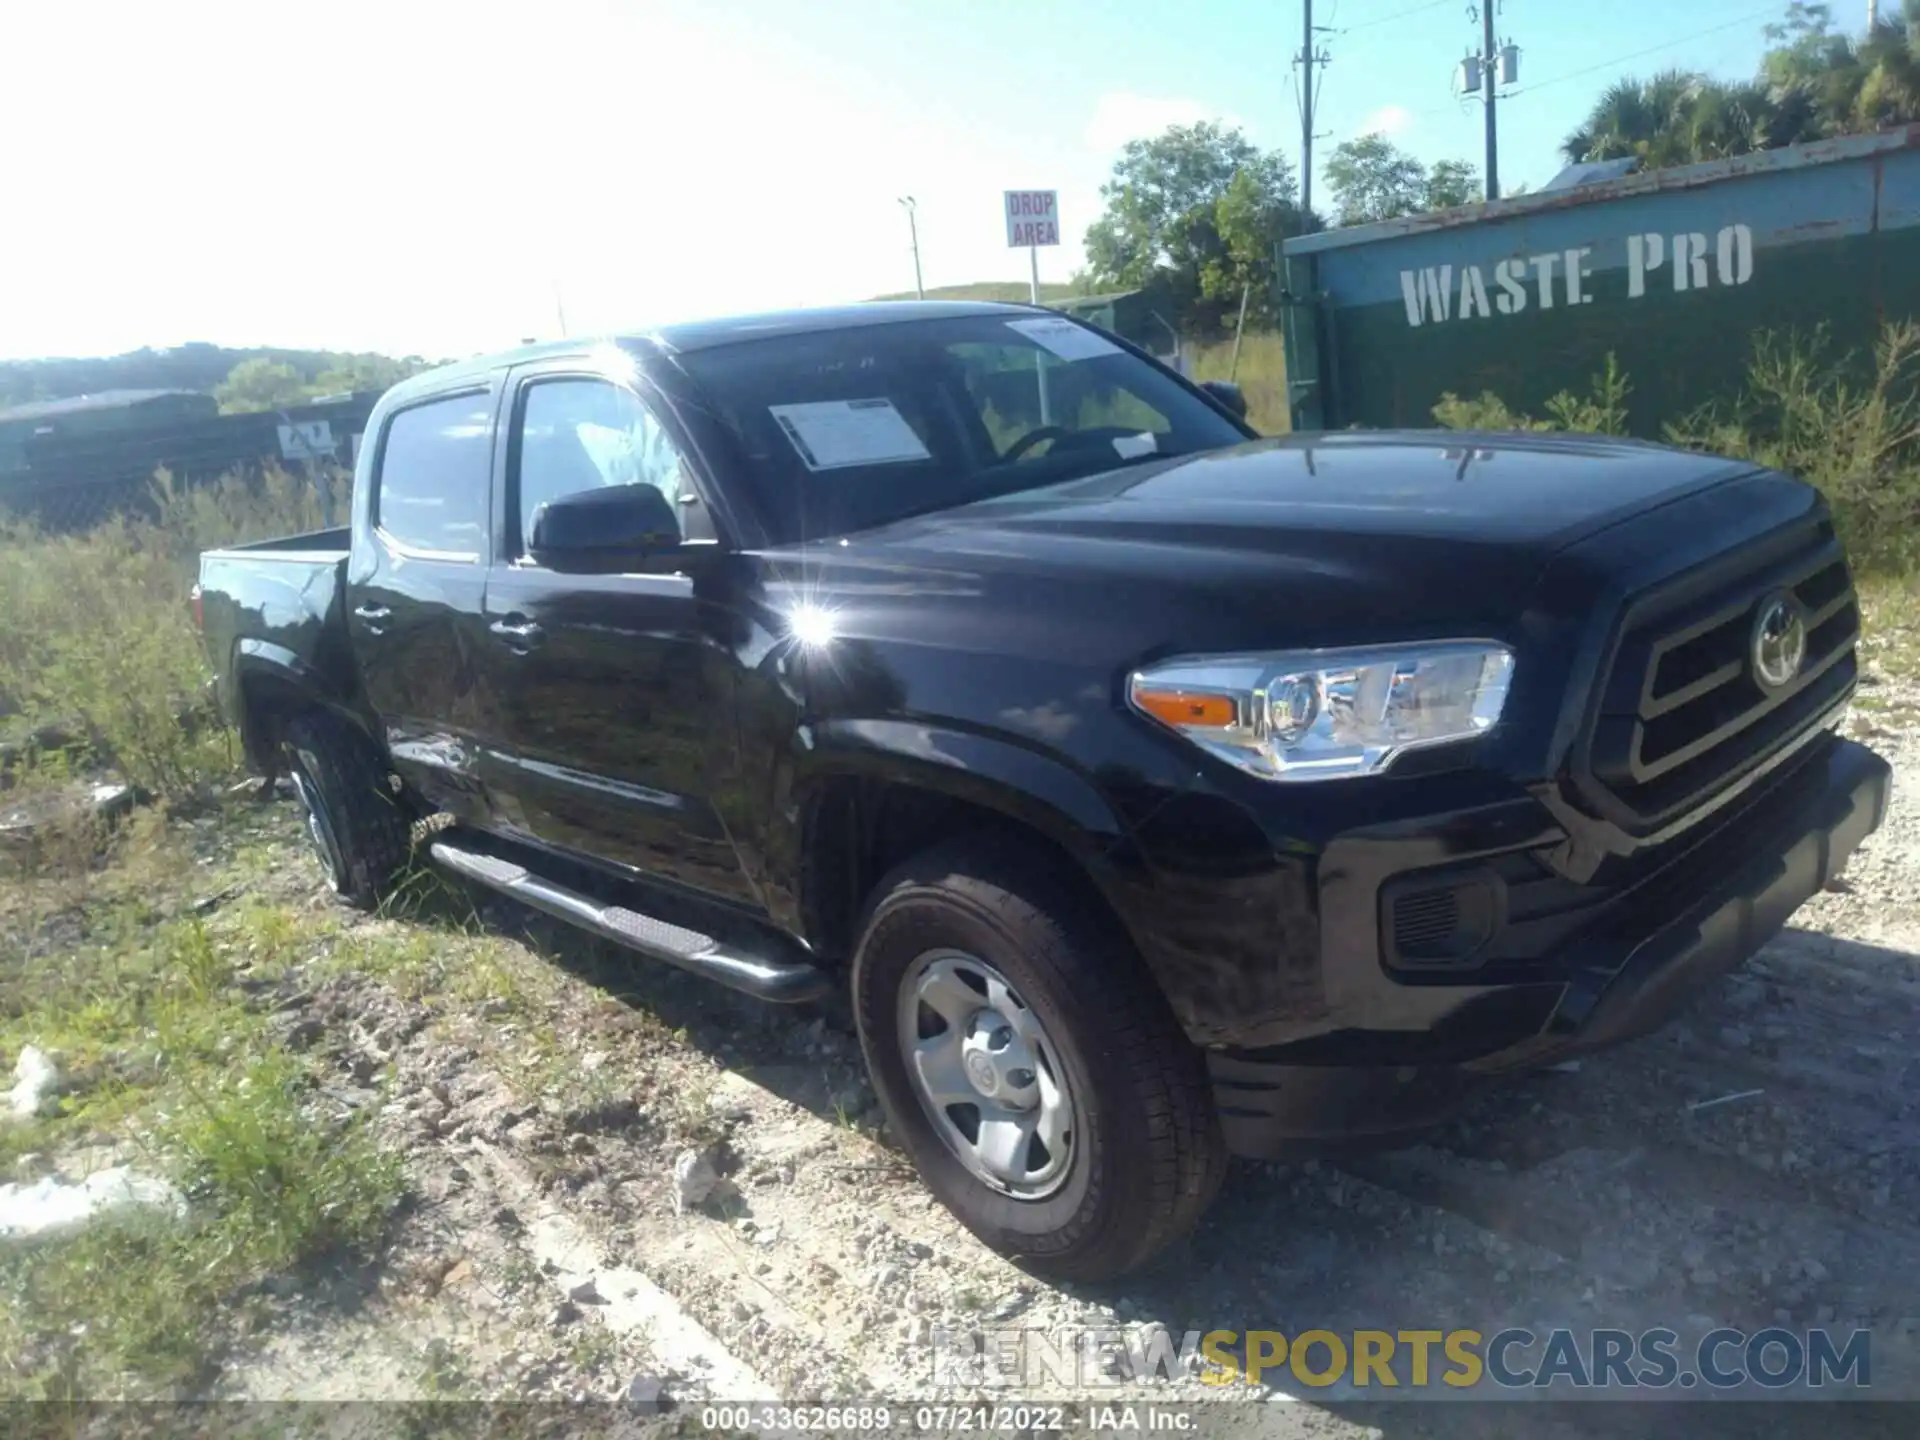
left=0, top=470, right=346, bottom=797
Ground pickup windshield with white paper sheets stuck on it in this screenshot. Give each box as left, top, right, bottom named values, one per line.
left=680, top=311, right=1246, bottom=541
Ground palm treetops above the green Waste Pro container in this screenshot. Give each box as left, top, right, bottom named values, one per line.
left=1563, top=0, right=1920, bottom=169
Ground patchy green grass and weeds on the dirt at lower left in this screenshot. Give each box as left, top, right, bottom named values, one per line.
left=0, top=810, right=403, bottom=1400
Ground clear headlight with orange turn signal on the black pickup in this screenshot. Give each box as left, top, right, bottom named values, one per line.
left=1127, top=639, right=1513, bottom=780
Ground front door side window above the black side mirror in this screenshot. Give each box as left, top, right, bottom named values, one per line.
left=515, top=380, right=685, bottom=553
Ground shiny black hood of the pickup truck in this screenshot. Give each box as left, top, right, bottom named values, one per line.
left=781, top=432, right=1753, bottom=659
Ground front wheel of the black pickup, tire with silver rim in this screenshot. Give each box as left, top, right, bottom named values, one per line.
left=852, top=839, right=1227, bottom=1281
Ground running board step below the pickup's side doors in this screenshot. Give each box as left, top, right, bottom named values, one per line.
left=430, top=841, right=831, bottom=1004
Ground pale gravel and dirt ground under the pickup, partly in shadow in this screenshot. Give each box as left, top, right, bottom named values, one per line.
left=15, top=678, right=1920, bottom=1434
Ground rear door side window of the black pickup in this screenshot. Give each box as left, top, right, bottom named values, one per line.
left=374, top=394, right=493, bottom=561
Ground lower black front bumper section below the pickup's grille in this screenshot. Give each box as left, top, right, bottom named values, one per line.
left=1208, top=739, right=1891, bottom=1158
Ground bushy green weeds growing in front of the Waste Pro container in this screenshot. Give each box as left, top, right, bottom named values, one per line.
left=1434, top=321, right=1920, bottom=576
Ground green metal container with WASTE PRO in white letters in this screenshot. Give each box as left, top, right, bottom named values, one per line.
left=1283, top=125, right=1920, bottom=436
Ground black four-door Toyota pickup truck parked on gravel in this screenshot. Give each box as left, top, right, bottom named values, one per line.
left=200, top=303, right=1889, bottom=1277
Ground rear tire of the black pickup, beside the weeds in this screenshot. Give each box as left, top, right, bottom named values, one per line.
left=282, top=712, right=413, bottom=910
